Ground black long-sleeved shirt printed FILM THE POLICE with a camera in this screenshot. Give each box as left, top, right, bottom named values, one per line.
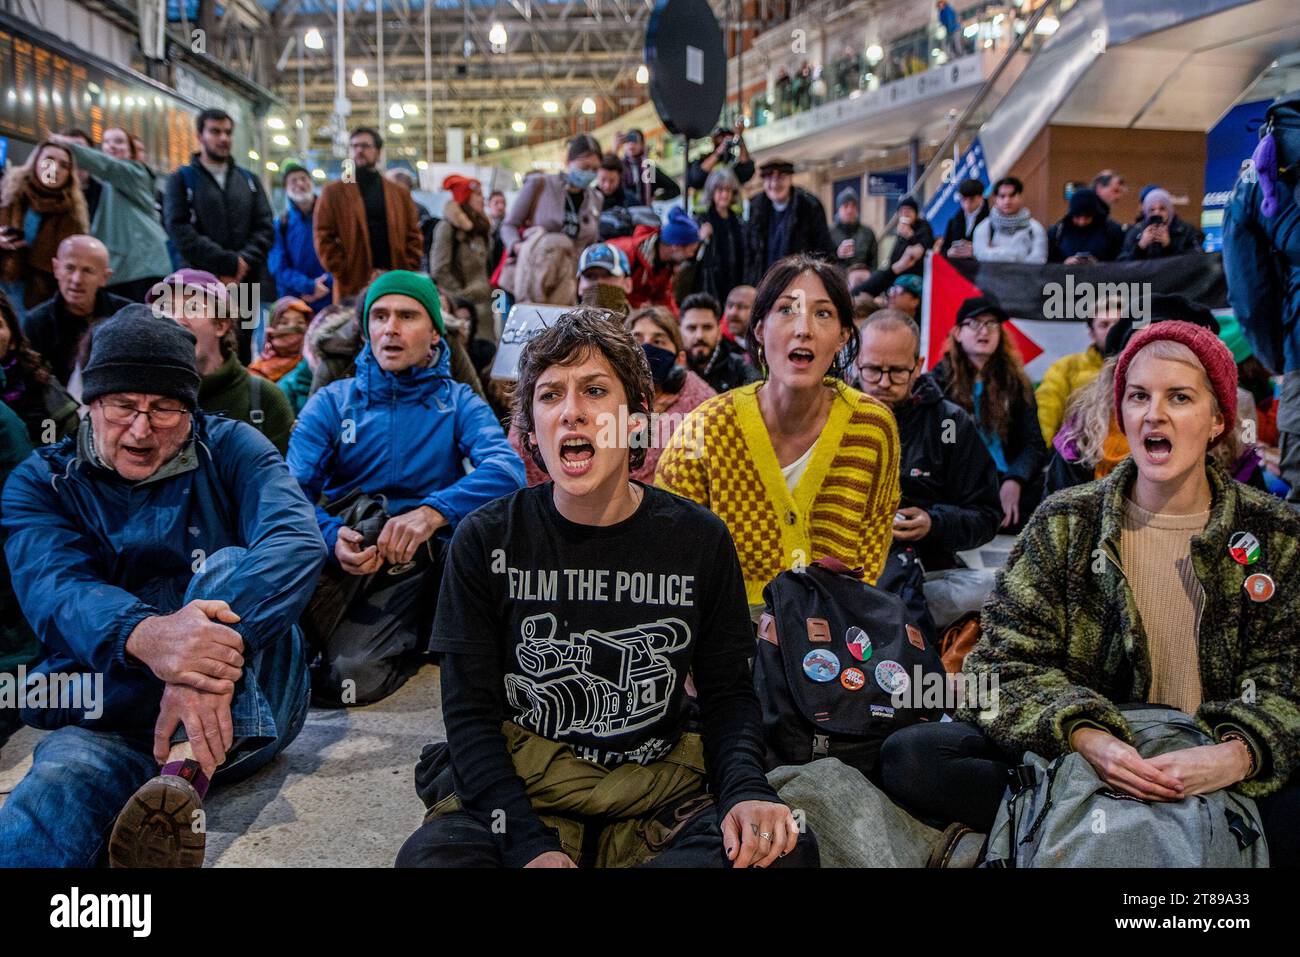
left=430, top=482, right=776, bottom=863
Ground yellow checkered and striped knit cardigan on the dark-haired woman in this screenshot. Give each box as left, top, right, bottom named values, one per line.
left=655, top=380, right=898, bottom=606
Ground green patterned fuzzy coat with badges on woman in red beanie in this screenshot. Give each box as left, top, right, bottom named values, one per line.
left=957, top=458, right=1300, bottom=797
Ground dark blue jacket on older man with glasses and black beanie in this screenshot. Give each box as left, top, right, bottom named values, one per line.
left=0, top=412, right=325, bottom=732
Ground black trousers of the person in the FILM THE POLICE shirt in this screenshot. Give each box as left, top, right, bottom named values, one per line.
left=397, top=810, right=822, bottom=867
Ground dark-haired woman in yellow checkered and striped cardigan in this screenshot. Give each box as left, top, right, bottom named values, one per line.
left=655, top=256, right=898, bottom=607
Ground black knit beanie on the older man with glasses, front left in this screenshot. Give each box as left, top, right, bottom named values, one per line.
left=82, top=303, right=200, bottom=410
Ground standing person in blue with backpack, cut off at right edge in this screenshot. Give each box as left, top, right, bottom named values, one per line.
left=1223, top=92, right=1300, bottom=507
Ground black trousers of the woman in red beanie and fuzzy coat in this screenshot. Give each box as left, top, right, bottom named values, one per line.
left=880, top=722, right=1300, bottom=867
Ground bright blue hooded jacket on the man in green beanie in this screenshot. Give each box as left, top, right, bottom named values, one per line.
left=287, top=343, right=524, bottom=554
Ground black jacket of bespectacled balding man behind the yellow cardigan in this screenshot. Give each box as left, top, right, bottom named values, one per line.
left=893, top=374, right=1002, bottom=572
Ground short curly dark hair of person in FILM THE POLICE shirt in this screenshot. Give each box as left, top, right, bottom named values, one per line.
left=512, top=306, right=654, bottom=472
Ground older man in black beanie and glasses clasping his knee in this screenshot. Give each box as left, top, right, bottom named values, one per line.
left=0, top=304, right=325, bottom=867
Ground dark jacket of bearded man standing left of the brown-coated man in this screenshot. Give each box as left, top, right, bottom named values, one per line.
left=163, top=153, right=276, bottom=282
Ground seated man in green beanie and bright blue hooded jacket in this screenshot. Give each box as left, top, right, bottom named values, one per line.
left=287, top=269, right=524, bottom=705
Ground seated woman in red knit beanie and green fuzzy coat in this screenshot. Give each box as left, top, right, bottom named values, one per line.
left=881, top=320, right=1300, bottom=867
